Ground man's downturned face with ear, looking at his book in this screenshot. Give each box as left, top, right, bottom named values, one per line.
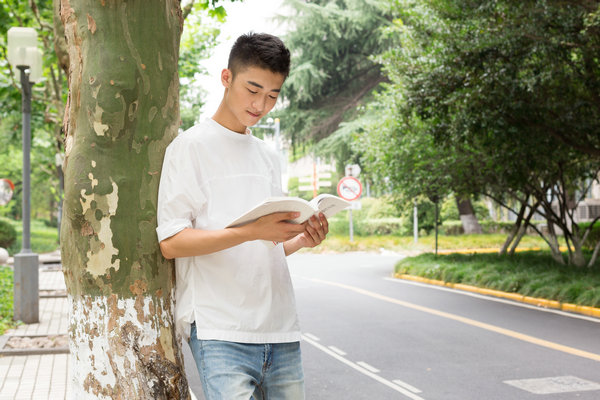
left=221, top=67, right=285, bottom=132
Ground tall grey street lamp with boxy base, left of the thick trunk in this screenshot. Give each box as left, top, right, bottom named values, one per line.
left=7, top=28, right=42, bottom=324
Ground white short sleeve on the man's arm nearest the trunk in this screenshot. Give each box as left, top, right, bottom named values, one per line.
left=156, top=138, right=206, bottom=242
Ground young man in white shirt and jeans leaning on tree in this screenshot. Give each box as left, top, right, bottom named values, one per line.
left=157, top=34, right=328, bottom=400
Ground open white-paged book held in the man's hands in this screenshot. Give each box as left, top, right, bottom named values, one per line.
left=227, top=194, right=350, bottom=228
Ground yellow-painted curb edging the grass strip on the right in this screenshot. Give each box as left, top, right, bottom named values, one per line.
left=394, top=273, right=600, bottom=318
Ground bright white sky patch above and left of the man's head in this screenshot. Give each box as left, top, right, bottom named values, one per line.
left=199, top=0, right=285, bottom=121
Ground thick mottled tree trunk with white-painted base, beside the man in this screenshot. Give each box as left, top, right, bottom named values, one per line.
left=60, top=0, right=190, bottom=399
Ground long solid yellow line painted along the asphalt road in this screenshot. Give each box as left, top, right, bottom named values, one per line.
left=307, top=278, right=600, bottom=362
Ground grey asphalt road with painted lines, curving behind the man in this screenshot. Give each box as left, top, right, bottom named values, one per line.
left=186, top=253, right=600, bottom=400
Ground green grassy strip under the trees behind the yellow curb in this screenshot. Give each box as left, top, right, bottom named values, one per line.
left=396, top=251, right=600, bottom=307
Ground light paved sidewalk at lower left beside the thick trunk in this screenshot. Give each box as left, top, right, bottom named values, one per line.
left=0, top=252, right=70, bottom=400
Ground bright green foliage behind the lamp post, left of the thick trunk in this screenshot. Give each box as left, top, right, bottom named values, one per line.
left=0, top=2, right=67, bottom=218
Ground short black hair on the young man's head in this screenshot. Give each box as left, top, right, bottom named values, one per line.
left=227, top=32, right=290, bottom=78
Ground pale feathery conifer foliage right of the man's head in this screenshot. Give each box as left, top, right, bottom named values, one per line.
left=278, top=0, right=392, bottom=158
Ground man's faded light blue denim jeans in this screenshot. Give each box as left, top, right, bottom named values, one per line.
left=190, top=323, right=304, bottom=400
